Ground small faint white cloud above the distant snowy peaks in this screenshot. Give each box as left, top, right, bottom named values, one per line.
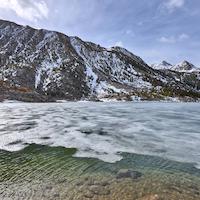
left=158, top=33, right=190, bottom=44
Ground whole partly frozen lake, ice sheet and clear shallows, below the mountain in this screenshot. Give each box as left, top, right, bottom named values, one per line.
left=0, top=102, right=200, bottom=200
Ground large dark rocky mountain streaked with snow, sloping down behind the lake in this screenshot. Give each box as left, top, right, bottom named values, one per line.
left=0, top=20, right=200, bottom=102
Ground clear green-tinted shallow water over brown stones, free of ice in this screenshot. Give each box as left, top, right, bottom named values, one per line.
left=0, top=144, right=200, bottom=200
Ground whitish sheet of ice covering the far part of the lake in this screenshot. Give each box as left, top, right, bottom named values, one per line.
left=0, top=102, right=200, bottom=167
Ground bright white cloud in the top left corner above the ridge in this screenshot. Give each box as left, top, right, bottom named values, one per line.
left=0, top=0, right=49, bottom=22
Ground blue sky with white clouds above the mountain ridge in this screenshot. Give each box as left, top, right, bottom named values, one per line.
left=0, top=0, right=200, bottom=67
